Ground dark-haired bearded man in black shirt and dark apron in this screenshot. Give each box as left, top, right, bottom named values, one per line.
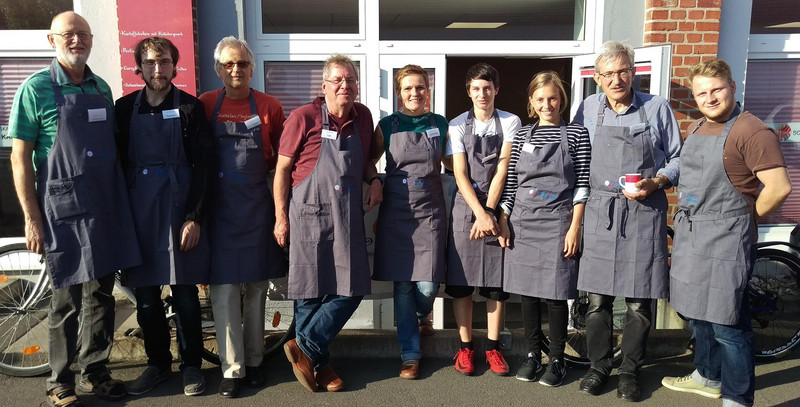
left=115, top=37, right=211, bottom=396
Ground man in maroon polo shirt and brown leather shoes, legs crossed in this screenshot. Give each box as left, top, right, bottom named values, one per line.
left=274, top=55, right=383, bottom=391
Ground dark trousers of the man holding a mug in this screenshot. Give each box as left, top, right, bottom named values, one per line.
left=586, top=293, right=652, bottom=375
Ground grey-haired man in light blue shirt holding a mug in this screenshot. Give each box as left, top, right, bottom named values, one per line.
left=575, top=41, right=682, bottom=401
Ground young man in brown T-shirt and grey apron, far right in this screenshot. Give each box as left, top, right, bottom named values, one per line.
left=661, top=59, right=792, bottom=406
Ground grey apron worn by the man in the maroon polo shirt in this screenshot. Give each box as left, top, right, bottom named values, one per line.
left=289, top=101, right=371, bottom=299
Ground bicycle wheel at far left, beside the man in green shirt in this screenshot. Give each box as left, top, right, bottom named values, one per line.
left=0, top=243, right=53, bottom=376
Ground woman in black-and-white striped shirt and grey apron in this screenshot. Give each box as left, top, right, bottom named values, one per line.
left=499, top=71, right=591, bottom=386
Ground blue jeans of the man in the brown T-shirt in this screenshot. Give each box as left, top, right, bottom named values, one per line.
left=689, top=293, right=756, bottom=406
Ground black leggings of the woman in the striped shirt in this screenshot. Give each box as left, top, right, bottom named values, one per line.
left=520, top=295, right=569, bottom=360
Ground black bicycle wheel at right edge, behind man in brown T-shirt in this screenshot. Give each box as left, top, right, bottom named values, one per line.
left=748, top=249, right=800, bottom=360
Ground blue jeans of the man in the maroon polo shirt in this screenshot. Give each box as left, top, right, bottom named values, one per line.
left=294, top=295, right=364, bottom=371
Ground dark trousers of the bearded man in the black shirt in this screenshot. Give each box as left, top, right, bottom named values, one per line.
left=135, top=284, right=203, bottom=370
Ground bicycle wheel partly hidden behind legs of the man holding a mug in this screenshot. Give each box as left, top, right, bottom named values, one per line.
left=542, top=291, right=627, bottom=367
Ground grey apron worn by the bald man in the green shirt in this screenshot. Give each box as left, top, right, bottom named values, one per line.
left=36, top=59, right=141, bottom=288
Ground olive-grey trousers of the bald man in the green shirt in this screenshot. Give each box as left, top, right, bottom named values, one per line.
left=47, top=273, right=115, bottom=391
